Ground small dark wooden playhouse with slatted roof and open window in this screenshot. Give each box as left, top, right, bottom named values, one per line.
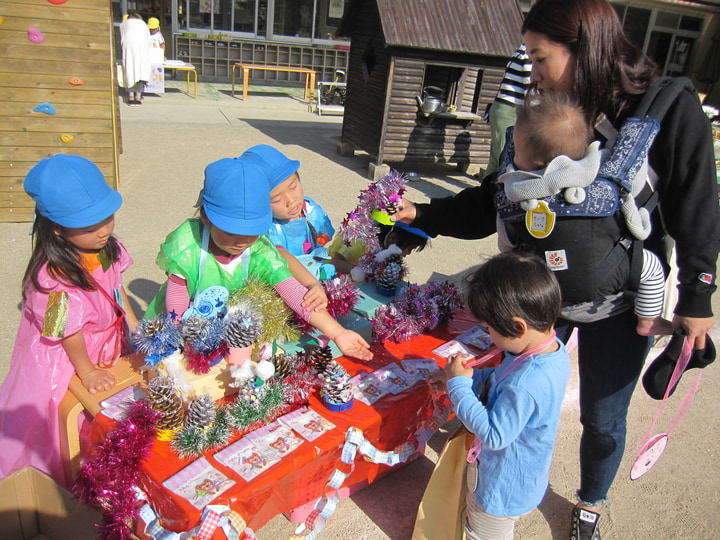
left=339, top=0, right=522, bottom=177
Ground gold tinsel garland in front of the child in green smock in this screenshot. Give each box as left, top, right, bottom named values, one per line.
left=227, top=278, right=300, bottom=343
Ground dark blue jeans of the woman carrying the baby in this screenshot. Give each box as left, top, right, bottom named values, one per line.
left=556, top=310, right=652, bottom=506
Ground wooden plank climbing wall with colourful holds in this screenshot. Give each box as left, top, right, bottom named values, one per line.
left=0, top=0, right=119, bottom=222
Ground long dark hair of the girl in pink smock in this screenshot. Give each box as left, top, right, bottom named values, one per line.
left=23, top=214, right=120, bottom=298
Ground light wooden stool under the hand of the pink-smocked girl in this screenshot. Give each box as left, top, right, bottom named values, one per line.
left=58, top=354, right=145, bottom=486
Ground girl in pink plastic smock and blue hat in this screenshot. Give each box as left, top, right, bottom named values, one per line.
left=0, top=155, right=136, bottom=484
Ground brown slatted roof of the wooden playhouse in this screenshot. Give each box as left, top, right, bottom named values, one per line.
left=339, top=0, right=522, bottom=56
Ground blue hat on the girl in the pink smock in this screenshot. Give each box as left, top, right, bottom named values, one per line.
left=23, top=154, right=122, bottom=229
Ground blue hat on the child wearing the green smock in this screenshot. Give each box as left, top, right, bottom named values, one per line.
left=200, top=156, right=272, bottom=236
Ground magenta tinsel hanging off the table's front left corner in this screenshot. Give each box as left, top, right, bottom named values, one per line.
left=73, top=402, right=160, bottom=540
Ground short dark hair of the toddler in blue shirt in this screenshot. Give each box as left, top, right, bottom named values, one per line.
left=465, top=252, right=561, bottom=337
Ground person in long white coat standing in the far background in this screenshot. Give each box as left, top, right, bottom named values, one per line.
left=120, top=13, right=151, bottom=105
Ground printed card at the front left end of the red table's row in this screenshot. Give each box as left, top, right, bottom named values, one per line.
left=163, top=457, right=235, bottom=509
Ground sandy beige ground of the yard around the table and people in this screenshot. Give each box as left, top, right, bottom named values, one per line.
left=0, top=82, right=720, bottom=540
